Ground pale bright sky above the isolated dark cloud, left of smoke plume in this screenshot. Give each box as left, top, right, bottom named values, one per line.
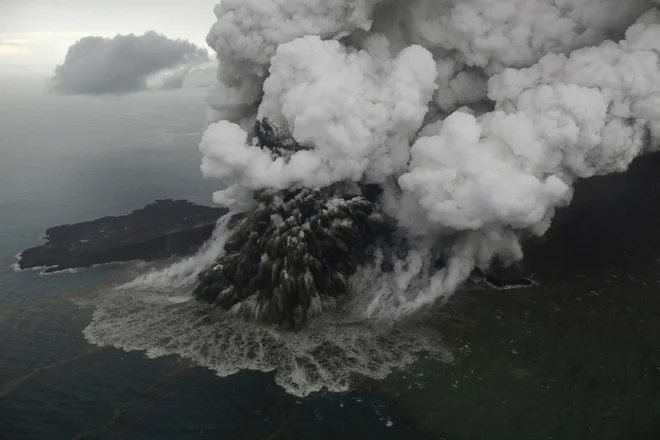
left=0, top=0, right=220, bottom=75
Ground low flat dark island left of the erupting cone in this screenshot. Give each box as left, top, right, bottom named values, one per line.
left=18, top=199, right=227, bottom=272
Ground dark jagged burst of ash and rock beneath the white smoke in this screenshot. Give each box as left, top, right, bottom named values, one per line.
left=194, top=188, right=382, bottom=328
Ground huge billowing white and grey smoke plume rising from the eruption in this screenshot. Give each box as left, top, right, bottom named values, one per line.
left=200, top=0, right=660, bottom=322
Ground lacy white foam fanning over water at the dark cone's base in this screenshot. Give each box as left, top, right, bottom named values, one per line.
left=83, top=289, right=452, bottom=396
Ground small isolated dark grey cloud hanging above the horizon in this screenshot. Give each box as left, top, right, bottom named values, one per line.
left=50, top=31, right=215, bottom=95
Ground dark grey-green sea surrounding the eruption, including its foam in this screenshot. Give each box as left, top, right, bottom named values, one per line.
left=0, top=81, right=660, bottom=440
